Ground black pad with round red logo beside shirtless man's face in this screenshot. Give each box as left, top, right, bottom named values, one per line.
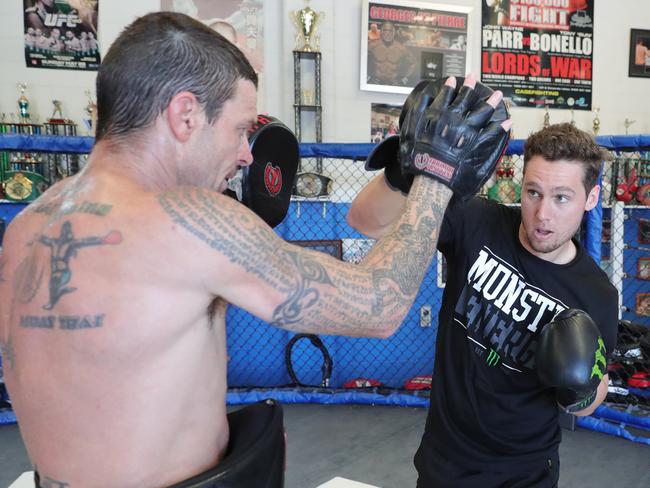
left=225, top=115, right=300, bottom=227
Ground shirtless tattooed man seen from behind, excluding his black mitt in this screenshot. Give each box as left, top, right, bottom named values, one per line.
left=0, top=12, right=506, bottom=488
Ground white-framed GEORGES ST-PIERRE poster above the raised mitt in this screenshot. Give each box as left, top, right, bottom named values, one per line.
left=360, top=0, right=472, bottom=93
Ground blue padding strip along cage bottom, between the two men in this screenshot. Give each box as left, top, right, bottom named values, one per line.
left=226, top=388, right=429, bottom=407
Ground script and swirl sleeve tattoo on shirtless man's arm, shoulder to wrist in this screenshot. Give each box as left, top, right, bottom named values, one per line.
left=159, top=178, right=451, bottom=336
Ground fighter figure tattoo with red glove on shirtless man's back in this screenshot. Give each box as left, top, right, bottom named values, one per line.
left=38, top=220, right=122, bottom=310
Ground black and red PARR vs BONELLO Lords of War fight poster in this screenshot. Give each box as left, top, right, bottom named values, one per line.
left=481, top=0, right=595, bottom=110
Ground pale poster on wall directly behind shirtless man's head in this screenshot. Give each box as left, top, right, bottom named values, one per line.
left=160, top=0, right=264, bottom=76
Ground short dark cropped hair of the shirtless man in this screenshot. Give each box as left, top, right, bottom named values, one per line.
left=96, top=12, right=257, bottom=140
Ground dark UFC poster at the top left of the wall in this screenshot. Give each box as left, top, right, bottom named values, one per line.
left=23, top=0, right=100, bottom=71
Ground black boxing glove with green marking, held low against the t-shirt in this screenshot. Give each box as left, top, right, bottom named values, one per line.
left=535, top=308, right=607, bottom=413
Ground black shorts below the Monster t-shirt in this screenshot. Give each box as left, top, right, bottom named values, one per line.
left=414, top=445, right=560, bottom=488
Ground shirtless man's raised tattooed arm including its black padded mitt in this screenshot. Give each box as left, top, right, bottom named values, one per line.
left=159, top=74, right=509, bottom=337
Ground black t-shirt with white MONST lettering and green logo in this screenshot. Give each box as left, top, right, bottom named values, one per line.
left=422, top=198, right=618, bottom=471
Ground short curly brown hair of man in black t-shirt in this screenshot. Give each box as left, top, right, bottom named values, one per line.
left=524, top=122, right=609, bottom=195
